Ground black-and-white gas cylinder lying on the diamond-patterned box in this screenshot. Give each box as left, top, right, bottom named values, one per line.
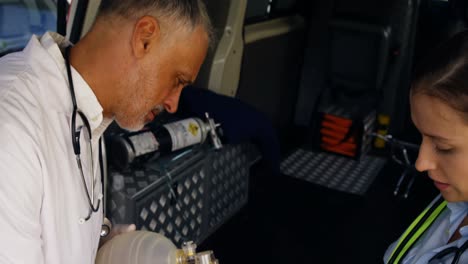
left=110, top=116, right=221, bottom=168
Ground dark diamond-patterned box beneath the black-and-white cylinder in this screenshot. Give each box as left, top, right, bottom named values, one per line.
left=108, top=145, right=258, bottom=246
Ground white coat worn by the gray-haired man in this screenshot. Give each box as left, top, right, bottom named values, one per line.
left=0, top=33, right=110, bottom=264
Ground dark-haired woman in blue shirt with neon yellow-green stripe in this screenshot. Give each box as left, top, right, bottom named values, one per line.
left=384, top=31, right=468, bottom=264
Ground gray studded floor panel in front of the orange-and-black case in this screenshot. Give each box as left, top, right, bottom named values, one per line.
left=281, top=149, right=387, bottom=195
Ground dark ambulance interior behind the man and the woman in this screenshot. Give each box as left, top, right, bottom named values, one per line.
left=0, top=0, right=468, bottom=264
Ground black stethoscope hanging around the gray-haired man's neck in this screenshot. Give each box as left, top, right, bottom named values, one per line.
left=64, top=46, right=110, bottom=236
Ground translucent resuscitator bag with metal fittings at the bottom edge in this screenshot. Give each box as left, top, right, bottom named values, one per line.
left=95, top=231, right=218, bottom=264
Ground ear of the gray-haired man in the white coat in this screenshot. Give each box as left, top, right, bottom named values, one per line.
left=132, top=16, right=161, bottom=58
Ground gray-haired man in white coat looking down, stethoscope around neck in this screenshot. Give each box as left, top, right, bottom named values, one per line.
left=0, top=0, right=212, bottom=264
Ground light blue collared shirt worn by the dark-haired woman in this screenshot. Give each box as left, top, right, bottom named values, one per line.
left=384, top=197, right=468, bottom=264
